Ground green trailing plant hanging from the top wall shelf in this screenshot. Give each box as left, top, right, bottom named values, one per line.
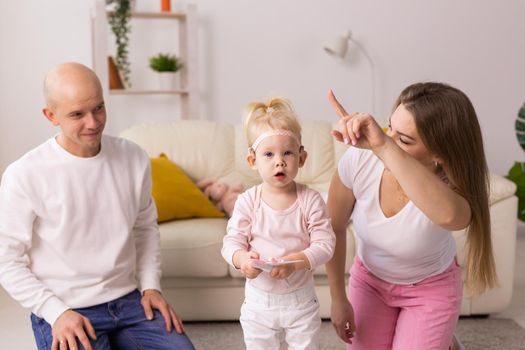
left=106, top=0, right=131, bottom=87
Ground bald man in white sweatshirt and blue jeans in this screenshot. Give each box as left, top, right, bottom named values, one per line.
left=0, top=63, right=193, bottom=350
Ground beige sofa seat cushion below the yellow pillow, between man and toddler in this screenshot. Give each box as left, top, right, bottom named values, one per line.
left=159, top=218, right=228, bottom=278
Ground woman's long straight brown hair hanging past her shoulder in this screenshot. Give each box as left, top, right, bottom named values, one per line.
left=394, top=83, right=497, bottom=295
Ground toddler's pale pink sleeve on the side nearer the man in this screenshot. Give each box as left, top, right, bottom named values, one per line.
left=221, top=190, right=253, bottom=267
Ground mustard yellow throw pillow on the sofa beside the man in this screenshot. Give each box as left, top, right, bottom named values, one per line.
left=151, top=154, right=224, bottom=222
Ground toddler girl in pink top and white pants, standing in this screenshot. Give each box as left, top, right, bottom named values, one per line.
left=222, top=98, right=335, bottom=350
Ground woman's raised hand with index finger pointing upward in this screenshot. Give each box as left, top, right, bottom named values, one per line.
left=328, top=90, right=388, bottom=150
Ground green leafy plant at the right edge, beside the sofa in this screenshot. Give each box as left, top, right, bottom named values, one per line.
left=507, top=103, right=525, bottom=222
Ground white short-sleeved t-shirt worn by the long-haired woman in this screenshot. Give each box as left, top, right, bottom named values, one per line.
left=338, top=147, right=456, bottom=284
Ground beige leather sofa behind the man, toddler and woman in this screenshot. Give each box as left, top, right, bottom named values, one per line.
left=121, top=121, right=517, bottom=320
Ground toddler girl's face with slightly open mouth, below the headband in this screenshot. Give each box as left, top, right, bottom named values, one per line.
left=248, top=135, right=306, bottom=188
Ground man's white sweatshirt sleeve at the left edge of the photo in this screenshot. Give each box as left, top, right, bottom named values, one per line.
left=0, top=168, right=69, bottom=325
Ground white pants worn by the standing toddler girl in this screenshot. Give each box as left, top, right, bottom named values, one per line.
left=240, top=283, right=321, bottom=350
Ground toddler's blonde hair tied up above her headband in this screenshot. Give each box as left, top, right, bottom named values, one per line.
left=244, top=97, right=301, bottom=147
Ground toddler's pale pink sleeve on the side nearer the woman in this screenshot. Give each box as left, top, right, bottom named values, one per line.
left=303, top=190, right=335, bottom=270
